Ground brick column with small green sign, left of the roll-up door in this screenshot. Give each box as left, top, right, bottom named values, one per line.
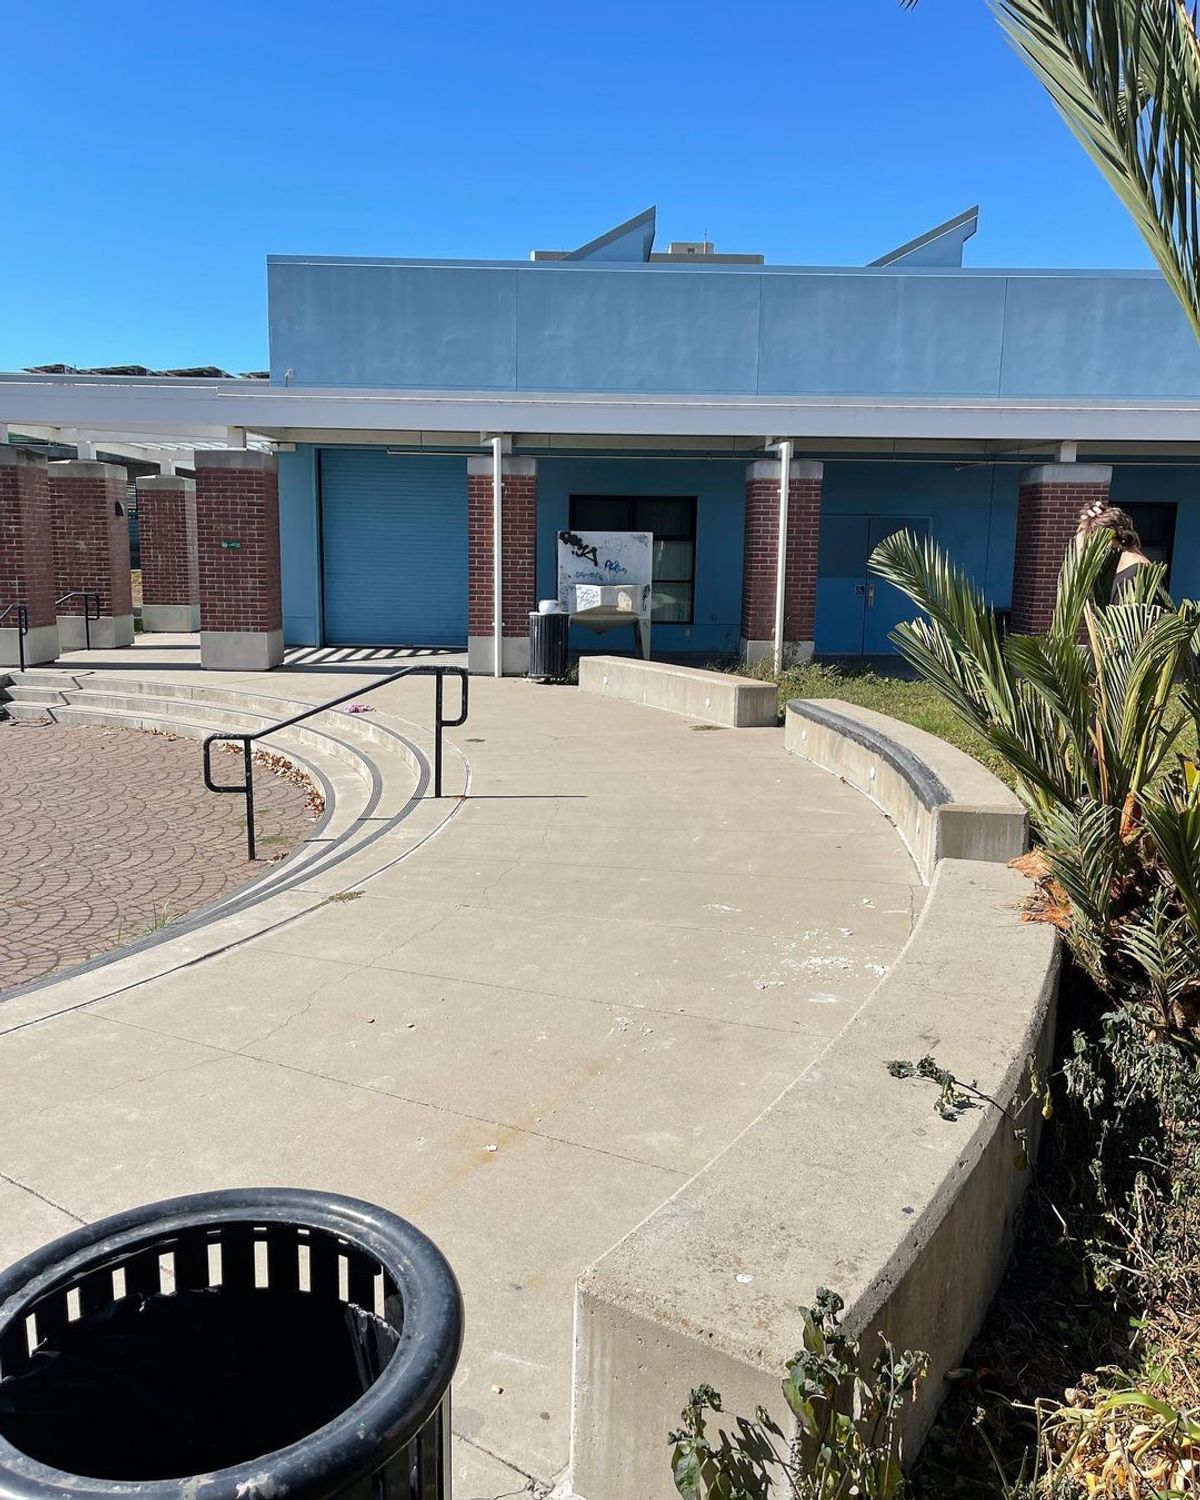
left=195, top=449, right=284, bottom=672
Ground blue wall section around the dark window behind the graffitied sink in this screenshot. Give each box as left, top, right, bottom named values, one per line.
left=537, top=459, right=746, bottom=654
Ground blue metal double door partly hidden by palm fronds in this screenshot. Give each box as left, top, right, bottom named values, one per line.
left=816, top=515, right=929, bottom=656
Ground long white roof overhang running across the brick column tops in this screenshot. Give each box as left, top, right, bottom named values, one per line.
left=0, top=375, right=1200, bottom=453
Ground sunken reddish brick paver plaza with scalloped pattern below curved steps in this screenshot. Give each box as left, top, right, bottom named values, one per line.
left=0, top=722, right=314, bottom=990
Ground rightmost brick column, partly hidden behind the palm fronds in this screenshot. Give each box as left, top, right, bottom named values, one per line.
left=1008, top=464, right=1113, bottom=636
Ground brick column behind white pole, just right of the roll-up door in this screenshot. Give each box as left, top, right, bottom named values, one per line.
left=467, top=456, right=537, bottom=677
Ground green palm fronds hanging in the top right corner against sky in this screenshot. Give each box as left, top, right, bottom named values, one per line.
left=902, top=0, right=1200, bottom=339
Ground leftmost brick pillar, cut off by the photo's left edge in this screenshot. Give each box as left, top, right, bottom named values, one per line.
left=0, top=443, right=59, bottom=666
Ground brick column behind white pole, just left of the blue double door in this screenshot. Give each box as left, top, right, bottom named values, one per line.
left=741, top=459, right=825, bottom=665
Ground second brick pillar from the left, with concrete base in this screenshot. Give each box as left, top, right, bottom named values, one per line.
left=47, top=459, right=134, bottom=651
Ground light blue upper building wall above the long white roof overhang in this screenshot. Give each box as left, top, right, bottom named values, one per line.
left=267, top=257, right=1200, bottom=399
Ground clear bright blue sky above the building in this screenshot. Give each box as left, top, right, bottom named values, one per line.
left=0, top=0, right=1151, bottom=371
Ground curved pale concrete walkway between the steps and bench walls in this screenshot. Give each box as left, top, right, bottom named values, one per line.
left=0, top=650, right=924, bottom=1500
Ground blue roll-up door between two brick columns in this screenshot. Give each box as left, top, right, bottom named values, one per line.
left=321, top=449, right=467, bottom=647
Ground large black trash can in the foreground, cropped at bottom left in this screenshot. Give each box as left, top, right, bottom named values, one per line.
left=0, top=1188, right=462, bottom=1500
